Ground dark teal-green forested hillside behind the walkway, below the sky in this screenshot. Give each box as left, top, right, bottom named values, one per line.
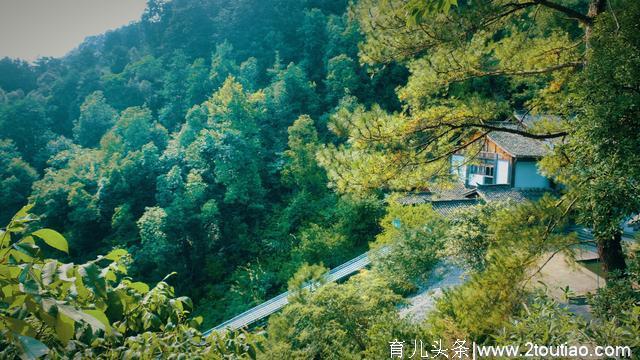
left=0, top=0, right=406, bottom=322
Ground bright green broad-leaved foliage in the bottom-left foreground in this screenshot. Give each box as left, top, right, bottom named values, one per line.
left=0, top=206, right=255, bottom=359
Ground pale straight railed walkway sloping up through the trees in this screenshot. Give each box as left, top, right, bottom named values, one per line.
left=203, top=247, right=388, bottom=336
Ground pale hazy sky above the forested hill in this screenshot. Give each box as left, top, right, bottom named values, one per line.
left=0, top=0, right=146, bottom=61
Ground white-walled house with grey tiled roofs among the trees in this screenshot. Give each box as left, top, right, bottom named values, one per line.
left=400, top=115, right=554, bottom=216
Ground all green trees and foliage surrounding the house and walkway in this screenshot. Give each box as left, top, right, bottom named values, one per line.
left=0, top=0, right=640, bottom=359
